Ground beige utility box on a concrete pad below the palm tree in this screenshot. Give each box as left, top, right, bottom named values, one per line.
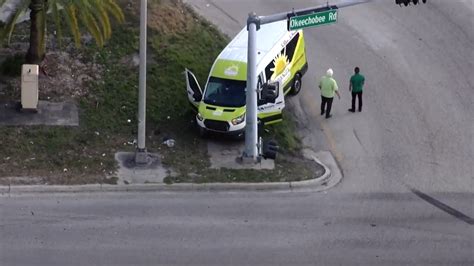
left=21, top=64, right=39, bottom=112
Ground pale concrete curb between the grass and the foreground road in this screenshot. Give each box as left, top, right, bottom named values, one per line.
left=0, top=156, right=331, bottom=196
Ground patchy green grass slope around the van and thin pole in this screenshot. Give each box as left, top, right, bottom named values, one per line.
left=0, top=1, right=321, bottom=184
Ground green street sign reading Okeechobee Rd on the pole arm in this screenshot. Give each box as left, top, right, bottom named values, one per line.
left=288, top=9, right=337, bottom=30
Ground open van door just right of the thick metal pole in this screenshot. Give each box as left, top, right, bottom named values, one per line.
left=257, top=82, right=285, bottom=125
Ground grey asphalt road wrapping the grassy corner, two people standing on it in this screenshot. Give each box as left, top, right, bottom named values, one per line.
left=0, top=0, right=474, bottom=265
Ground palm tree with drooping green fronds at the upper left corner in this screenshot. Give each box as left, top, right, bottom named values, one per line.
left=0, top=0, right=125, bottom=64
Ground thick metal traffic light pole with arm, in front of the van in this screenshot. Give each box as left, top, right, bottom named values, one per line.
left=242, top=0, right=426, bottom=163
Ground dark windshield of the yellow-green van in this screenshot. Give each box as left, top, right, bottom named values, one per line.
left=204, top=77, right=247, bottom=107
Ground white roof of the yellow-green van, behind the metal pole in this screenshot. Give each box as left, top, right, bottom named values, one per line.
left=217, top=20, right=288, bottom=63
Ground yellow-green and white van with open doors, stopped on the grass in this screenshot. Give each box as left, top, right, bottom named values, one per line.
left=185, top=21, right=308, bottom=135
